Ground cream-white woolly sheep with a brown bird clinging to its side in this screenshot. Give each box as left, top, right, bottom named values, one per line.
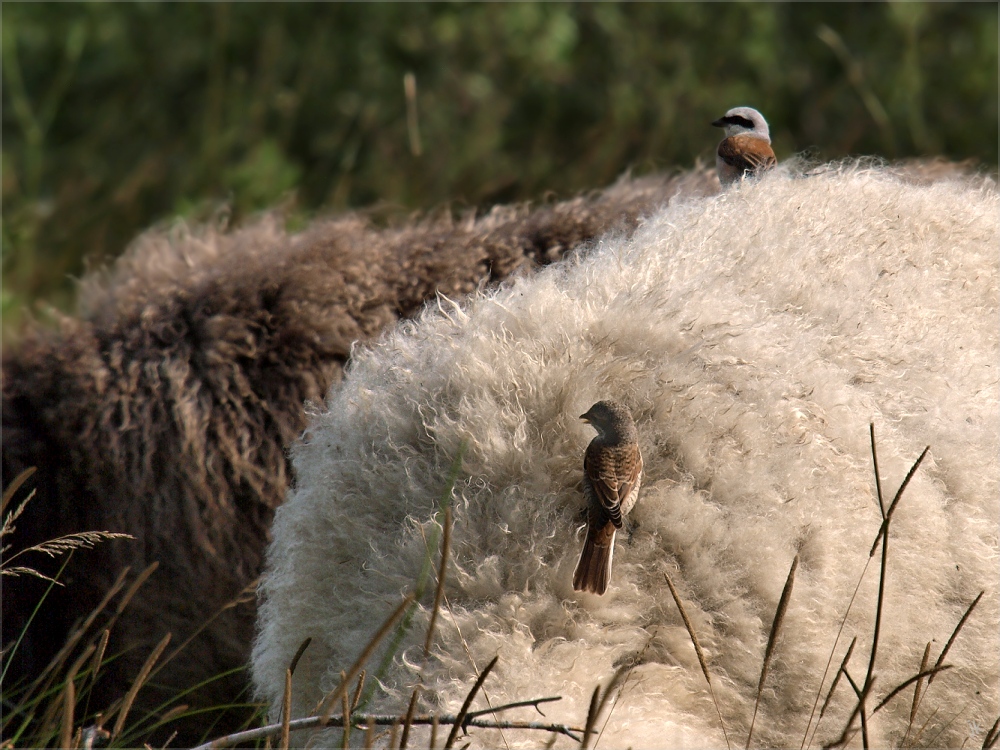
left=253, top=164, right=1000, bottom=747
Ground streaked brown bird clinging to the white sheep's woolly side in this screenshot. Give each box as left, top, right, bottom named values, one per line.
left=573, top=400, right=642, bottom=594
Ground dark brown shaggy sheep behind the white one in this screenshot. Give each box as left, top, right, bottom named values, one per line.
left=2, top=169, right=718, bottom=742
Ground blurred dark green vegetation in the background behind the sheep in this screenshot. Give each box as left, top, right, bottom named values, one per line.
left=2, top=2, right=998, bottom=332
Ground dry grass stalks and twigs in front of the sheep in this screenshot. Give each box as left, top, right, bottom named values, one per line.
left=2, top=426, right=1000, bottom=750
